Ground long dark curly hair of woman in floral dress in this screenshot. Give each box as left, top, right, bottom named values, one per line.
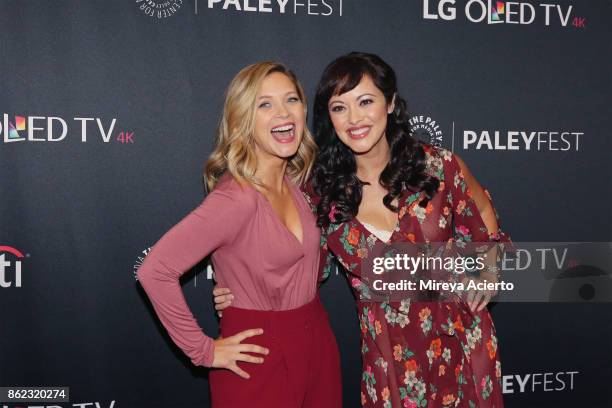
left=311, top=52, right=440, bottom=226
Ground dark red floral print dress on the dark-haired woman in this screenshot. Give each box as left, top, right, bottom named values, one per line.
left=306, top=144, right=511, bottom=408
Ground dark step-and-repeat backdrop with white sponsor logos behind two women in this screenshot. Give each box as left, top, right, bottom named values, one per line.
left=0, top=0, right=612, bottom=408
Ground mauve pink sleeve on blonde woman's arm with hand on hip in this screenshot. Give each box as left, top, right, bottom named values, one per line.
left=137, top=181, right=254, bottom=367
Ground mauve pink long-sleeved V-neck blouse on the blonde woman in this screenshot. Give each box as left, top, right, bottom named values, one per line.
left=137, top=173, right=320, bottom=367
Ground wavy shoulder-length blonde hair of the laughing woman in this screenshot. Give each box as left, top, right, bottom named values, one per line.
left=204, top=61, right=316, bottom=191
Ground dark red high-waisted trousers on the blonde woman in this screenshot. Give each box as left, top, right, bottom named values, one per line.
left=209, top=295, right=342, bottom=408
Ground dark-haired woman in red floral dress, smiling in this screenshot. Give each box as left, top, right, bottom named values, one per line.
left=311, top=53, right=509, bottom=408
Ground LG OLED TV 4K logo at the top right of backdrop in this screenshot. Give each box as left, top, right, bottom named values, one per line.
left=423, top=0, right=586, bottom=28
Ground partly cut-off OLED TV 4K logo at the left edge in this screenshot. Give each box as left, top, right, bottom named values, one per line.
left=0, top=113, right=134, bottom=144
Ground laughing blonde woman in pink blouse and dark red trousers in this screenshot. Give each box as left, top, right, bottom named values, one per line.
left=138, top=62, right=342, bottom=408
